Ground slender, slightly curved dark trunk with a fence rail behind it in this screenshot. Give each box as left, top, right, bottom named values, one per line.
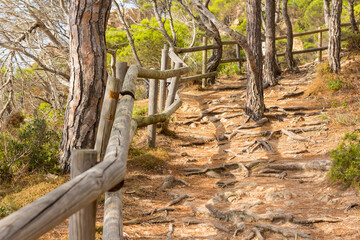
left=282, top=0, right=299, bottom=72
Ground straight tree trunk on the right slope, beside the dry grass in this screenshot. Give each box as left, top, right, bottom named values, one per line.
left=328, top=0, right=342, bottom=73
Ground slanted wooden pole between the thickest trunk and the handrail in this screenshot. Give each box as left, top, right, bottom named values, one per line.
left=95, top=77, right=120, bottom=161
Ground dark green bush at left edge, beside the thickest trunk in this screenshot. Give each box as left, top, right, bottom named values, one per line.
left=0, top=119, right=60, bottom=181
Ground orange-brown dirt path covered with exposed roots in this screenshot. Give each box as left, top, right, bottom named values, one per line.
left=124, top=64, right=360, bottom=239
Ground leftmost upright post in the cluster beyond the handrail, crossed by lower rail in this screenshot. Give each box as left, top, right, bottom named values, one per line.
left=147, top=76, right=159, bottom=147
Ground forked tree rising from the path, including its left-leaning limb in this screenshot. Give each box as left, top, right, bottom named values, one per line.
left=192, top=0, right=265, bottom=121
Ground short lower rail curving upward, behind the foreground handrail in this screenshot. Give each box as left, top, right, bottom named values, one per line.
left=134, top=99, right=182, bottom=127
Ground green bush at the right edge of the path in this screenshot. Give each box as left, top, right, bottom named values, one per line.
left=328, top=132, right=360, bottom=187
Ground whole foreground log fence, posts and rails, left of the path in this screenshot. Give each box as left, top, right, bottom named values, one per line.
left=0, top=50, right=194, bottom=240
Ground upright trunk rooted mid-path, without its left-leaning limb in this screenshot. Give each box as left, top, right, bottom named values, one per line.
left=245, top=0, right=265, bottom=121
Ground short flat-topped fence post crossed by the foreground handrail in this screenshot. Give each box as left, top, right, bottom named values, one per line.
left=69, top=149, right=97, bottom=240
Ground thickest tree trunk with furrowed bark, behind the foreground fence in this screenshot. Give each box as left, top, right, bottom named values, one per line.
left=60, top=0, right=111, bottom=172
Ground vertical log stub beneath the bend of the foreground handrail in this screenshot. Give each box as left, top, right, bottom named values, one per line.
left=103, top=189, right=123, bottom=240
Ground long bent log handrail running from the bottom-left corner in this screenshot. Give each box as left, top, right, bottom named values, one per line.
left=0, top=72, right=136, bottom=240
